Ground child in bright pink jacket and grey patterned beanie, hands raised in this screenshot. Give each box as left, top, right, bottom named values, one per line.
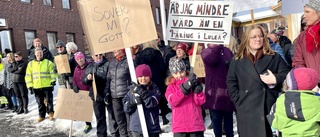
left=165, top=58, right=206, bottom=137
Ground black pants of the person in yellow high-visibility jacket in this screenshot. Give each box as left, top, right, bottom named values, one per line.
left=34, top=88, right=54, bottom=118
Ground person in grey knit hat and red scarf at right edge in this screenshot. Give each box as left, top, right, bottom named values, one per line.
left=292, top=0, right=320, bottom=81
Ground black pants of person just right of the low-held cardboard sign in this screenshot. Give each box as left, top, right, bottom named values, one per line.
left=93, top=101, right=107, bottom=137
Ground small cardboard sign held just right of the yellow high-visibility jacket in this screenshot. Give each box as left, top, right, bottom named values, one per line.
left=54, top=55, right=71, bottom=74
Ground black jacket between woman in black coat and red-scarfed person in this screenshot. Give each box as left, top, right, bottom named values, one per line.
left=279, top=36, right=294, bottom=65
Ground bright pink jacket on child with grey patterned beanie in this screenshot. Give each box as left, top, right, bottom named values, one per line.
left=165, top=77, right=206, bottom=133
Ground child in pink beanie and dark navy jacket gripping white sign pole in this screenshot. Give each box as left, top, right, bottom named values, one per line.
left=123, top=64, right=161, bottom=137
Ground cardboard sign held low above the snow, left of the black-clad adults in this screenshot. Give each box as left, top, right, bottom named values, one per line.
left=54, top=88, right=93, bottom=122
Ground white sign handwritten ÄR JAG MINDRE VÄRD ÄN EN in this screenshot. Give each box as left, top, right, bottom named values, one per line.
left=167, top=1, right=233, bottom=44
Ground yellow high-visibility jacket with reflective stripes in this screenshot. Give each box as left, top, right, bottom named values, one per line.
left=25, top=59, right=57, bottom=89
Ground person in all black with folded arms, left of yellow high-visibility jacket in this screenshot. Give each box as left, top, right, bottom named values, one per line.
left=9, top=51, right=29, bottom=114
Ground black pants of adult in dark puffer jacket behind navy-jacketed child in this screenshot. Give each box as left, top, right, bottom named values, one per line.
left=109, top=98, right=131, bottom=137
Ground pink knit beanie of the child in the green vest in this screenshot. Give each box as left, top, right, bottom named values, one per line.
left=286, top=68, right=319, bottom=90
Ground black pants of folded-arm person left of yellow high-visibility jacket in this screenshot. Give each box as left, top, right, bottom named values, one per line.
left=13, top=83, right=29, bottom=110
